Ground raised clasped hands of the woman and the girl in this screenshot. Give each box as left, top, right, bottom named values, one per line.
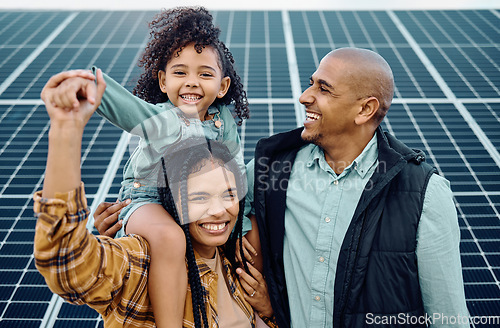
left=41, top=70, right=106, bottom=128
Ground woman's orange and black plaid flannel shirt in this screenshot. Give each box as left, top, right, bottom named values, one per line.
left=34, top=183, right=276, bottom=328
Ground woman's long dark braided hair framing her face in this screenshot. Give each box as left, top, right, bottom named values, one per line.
left=158, top=138, right=248, bottom=328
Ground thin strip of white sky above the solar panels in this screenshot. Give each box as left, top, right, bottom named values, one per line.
left=0, top=0, right=500, bottom=10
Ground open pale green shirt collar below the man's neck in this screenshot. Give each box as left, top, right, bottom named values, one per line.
left=307, top=134, right=378, bottom=178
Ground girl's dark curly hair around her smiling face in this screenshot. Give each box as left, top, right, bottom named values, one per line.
left=134, top=7, right=249, bottom=125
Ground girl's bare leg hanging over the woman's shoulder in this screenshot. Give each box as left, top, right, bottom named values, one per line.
left=125, top=204, right=188, bottom=328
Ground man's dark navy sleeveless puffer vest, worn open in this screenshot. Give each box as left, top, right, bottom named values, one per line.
left=254, top=128, right=435, bottom=328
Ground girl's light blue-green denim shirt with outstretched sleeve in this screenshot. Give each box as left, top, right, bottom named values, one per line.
left=93, top=68, right=245, bottom=187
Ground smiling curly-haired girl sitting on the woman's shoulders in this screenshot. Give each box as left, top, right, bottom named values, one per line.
left=51, top=8, right=248, bottom=328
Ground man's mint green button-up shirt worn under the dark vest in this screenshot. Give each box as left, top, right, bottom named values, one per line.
left=246, top=136, right=469, bottom=328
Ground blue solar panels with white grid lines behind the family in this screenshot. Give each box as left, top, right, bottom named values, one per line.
left=0, top=10, right=500, bottom=328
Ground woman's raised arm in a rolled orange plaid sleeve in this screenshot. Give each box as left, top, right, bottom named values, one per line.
left=34, top=72, right=154, bottom=327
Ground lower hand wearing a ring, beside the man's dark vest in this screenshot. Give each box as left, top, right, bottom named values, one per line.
left=236, top=263, right=274, bottom=318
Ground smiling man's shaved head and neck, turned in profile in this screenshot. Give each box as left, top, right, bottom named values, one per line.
left=299, top=48, right=394, bottom=174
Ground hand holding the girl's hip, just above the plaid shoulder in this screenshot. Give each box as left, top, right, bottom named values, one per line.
left=94, top=199, right=130, bottom=238
